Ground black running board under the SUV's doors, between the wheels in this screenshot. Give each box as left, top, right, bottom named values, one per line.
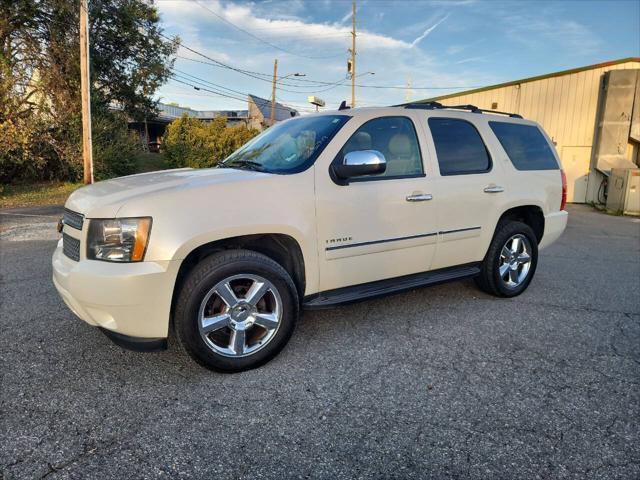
left=302, top=263, right=480, bottom=310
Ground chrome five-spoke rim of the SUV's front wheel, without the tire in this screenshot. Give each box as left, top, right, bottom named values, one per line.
left=198, top=274, right=282, bottom=357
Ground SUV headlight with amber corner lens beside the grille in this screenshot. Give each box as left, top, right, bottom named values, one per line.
left=87, top=217, right=151, bottom=262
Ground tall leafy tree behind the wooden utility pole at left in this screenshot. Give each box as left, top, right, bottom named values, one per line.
left=0, top=0, right=177, bottom=181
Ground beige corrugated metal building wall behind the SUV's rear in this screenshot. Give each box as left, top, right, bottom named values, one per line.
left=436, top=61, right=640, bottom=202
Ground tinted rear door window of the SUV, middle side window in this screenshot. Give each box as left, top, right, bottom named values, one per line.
left=429, top=117, right=491, bottom=175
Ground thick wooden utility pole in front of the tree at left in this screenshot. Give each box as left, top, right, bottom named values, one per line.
left=80, top=0, right=93, bottom=185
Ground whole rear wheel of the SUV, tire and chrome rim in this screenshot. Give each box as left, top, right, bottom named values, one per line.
left=475, top=220, right=538, bottom=297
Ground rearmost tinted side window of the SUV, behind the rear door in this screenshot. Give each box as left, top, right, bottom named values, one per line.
left=489, top=122, right=558, bottom=170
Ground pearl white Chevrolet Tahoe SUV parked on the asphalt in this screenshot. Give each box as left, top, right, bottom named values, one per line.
left=53, top=103, right=567, bottom=372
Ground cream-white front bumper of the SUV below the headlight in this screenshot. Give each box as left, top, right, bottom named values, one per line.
left=52, top=241, right=179, bottom=342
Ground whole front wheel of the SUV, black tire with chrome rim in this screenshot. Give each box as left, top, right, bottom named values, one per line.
left=174, top=250, right=300, bottom=373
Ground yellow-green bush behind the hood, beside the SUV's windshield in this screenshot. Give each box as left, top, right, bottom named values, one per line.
left=164, top=114, right=259, bottom=168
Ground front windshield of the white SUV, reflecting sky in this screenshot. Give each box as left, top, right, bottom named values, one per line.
left=220, top=115, right=349, bottom=173
